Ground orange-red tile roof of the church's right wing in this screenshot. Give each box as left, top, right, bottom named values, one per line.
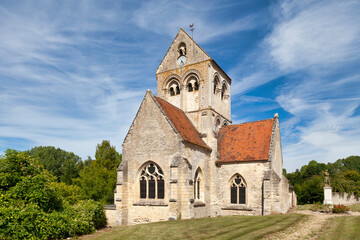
left=218, top=119, right=274, bottom=162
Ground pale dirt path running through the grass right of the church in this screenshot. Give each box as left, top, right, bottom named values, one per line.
left=265, top=210, right=360, bottom=240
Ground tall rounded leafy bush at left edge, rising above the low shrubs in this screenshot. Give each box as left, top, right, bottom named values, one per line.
left=0, top=150, right=62, bottom=212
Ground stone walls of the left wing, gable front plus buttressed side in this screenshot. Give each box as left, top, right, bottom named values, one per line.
left=116, top=90, right=210, bottom=225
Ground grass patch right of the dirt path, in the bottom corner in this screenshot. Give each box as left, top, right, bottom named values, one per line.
left=319, top=216, right=360, bottom=240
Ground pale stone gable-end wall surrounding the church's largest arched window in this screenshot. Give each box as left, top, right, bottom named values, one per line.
left=116, top=92, right=181, bottom=225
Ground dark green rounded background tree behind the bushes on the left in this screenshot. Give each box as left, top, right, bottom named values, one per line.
left=27, top=146, right=84, bottom=185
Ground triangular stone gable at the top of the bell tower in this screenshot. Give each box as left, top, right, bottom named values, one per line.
left=156, top=28, right=211, bottom=74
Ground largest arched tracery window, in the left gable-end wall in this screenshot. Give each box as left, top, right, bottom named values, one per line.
left=140, top=162, right=165, bottom=199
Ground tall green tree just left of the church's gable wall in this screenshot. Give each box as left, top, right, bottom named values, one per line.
left=75, top=140, right=121, bottom=203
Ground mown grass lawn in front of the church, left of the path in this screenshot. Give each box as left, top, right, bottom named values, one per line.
left=86, top=213, right=307, bottom=240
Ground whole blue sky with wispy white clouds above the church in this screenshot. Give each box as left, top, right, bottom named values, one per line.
left=0, top=0, right=360, bottom=171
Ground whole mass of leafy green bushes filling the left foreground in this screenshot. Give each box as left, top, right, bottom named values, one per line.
left=0, top=150, right=106, bottom=239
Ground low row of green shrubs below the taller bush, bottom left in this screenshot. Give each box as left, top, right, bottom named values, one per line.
left=0, top=200, right=106, bottom=239
